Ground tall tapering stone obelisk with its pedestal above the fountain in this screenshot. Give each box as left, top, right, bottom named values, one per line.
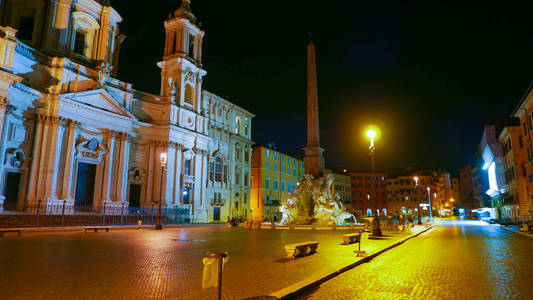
left=304, top=40, right=324, bottom=178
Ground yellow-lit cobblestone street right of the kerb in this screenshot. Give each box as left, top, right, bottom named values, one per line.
left=302, top=221, right=533, bottom=299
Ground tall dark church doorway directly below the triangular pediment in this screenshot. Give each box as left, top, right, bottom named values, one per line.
left=74, top=162, right=96, bottom=208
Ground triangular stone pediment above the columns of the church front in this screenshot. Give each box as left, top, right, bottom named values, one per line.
left=62, top=89, right=135, bottom=118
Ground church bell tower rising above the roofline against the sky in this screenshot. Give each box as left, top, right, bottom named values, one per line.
left=157, top=0, right=207, bottom=112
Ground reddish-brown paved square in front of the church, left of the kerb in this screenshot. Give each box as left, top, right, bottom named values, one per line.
left=0, top=226, right=420, bottom=300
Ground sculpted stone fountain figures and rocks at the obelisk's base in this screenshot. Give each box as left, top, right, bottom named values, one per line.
left=279, top=172, right=356, bottom=226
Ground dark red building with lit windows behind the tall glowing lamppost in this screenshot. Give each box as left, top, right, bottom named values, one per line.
left=347, top=172, right=388, bottom=216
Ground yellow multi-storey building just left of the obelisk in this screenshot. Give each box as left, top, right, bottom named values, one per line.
left=250, top=145, right=305, bottom=221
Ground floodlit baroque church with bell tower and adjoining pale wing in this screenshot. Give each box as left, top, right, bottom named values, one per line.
left=0, top=0, right=254, bottom=222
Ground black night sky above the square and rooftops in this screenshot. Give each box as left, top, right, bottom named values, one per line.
left=113, top=0, right=533, bottom=172
